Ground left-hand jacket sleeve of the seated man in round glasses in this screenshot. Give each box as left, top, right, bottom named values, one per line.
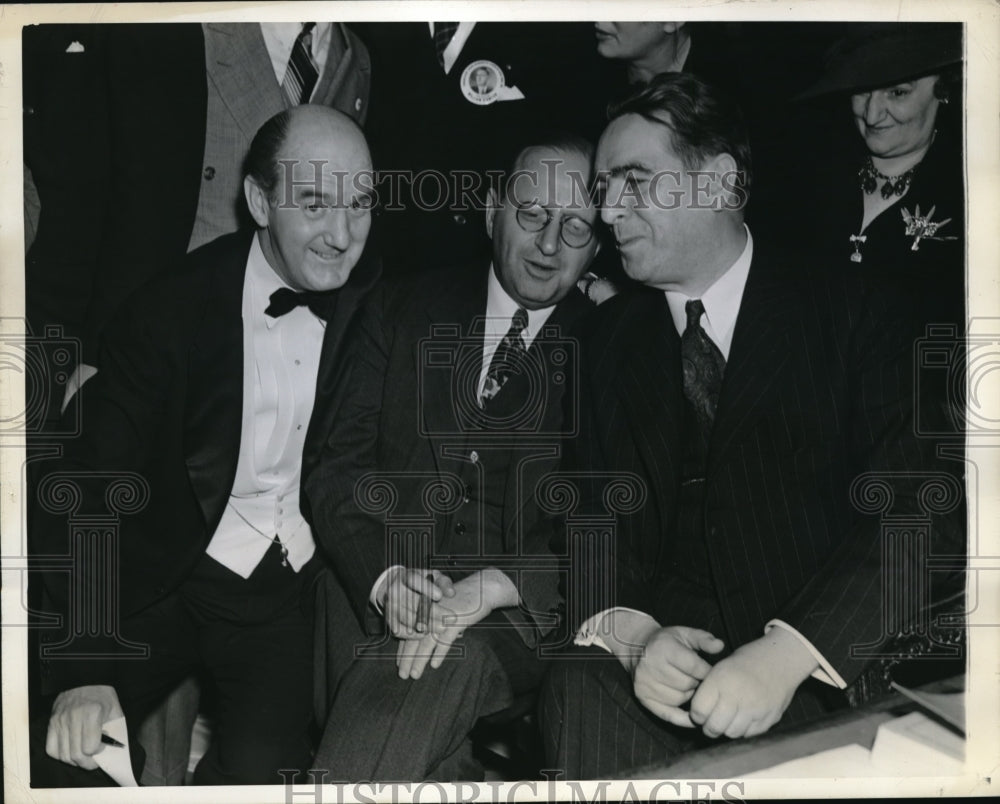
left=305, top=287, right=389, bottom=630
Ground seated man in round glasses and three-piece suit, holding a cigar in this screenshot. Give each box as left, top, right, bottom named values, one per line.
left=306, top=135, right=598, bottom=781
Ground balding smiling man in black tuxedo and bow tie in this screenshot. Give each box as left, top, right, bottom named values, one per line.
left=31, top=105, right=378, bottom=786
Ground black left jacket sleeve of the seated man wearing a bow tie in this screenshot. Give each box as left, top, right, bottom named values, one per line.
left=30, top=290, right=181, bottom=692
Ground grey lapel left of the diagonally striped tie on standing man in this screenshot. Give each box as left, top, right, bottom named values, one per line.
left=205, top=23, right=288, bottom=142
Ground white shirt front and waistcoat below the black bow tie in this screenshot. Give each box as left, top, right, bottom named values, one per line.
left=206, top=237, right=325, bottom=578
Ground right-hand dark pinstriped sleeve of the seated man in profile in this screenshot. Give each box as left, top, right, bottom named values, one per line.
left=776, top=282, right=965, bottom=684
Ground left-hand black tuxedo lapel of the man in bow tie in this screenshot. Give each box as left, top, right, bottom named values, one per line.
left=184, top=236, right=250, bottom=532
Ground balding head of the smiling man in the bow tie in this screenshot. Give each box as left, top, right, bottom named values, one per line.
left=243, top=105, right=374, bottom=291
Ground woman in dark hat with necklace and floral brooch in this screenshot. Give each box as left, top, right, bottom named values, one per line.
left=799, top=23, right=965, bottom=326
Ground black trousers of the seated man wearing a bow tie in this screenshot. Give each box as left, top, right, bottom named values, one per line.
left=32, top=546, right=316, bottom=787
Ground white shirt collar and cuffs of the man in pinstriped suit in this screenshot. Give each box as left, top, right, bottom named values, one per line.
left=574, top=226, right=847, bottom=689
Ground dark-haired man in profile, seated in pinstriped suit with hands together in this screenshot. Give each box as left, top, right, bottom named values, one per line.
left=542, top=74, right=964, bottom=778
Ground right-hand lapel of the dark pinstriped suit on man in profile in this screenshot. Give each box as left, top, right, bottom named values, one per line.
left=709, top=257, right=797, bottom=465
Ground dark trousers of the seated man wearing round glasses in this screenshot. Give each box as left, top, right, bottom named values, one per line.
left=313, top=613, right=545, bottom=782
